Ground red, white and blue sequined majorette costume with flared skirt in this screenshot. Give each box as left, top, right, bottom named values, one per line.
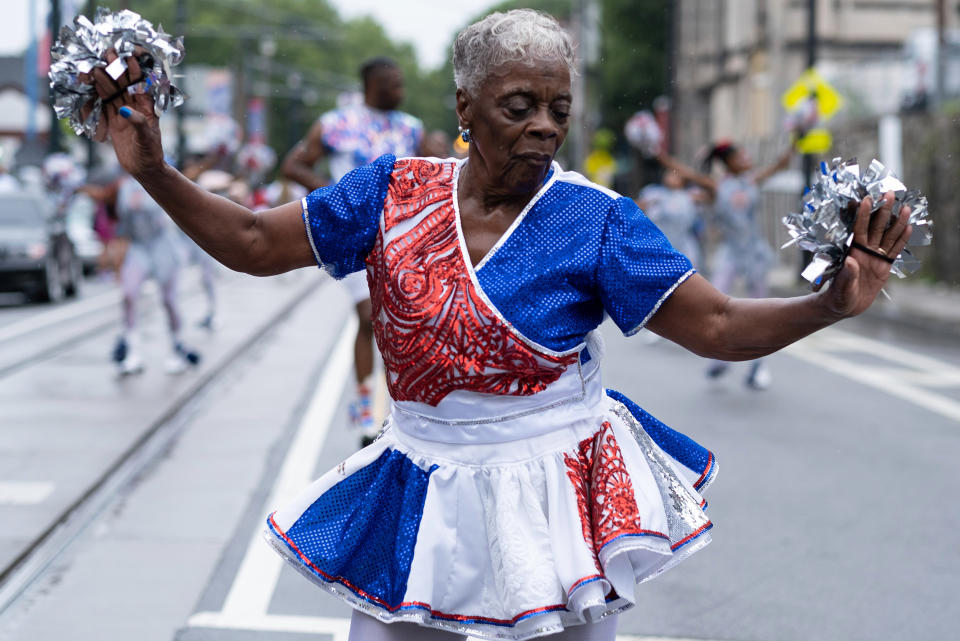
left=266, top=156, right=716, bottom=639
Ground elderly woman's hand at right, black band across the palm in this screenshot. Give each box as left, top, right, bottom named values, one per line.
left=816, top=192, right=912, bottom=319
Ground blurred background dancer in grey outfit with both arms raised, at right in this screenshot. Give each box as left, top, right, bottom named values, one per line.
left=657, top=141, right=793, bottom=390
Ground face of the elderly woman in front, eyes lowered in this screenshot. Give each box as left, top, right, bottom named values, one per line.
left=457, top=61, right=571, bottom=194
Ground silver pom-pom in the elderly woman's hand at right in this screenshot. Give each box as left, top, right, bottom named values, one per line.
left=783, top=158, right=933, bottom=283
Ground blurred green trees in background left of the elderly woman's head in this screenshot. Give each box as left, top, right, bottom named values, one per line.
left=110, top=0, right=456, bottom=155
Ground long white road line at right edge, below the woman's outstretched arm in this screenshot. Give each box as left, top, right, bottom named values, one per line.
left=784, top=330, right=960, bottom=422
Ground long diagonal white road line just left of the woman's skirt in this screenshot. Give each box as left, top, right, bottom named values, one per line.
left=216, top=315, right=357, bottom=625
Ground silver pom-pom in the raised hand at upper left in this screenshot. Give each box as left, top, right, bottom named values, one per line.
left=49, top=7, right=183, bottom=137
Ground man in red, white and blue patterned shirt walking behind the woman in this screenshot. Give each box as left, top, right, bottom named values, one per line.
left=282, top=58, right=424, bottom=445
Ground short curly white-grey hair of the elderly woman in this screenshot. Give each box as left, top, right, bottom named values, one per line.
left=453, top=9, right=577, bottom=92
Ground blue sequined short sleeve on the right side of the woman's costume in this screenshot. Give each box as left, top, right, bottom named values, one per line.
left=597, top=198, right=693, bottom=336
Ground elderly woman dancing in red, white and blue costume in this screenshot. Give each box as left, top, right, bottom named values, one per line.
left=86, top=10, right=910, bottom=641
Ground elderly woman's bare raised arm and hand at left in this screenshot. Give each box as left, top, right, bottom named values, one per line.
left=92, top=52, right=316, bottom=276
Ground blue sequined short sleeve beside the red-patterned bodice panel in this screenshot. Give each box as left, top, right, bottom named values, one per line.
left=302, top=154, right=396, bottom=278
